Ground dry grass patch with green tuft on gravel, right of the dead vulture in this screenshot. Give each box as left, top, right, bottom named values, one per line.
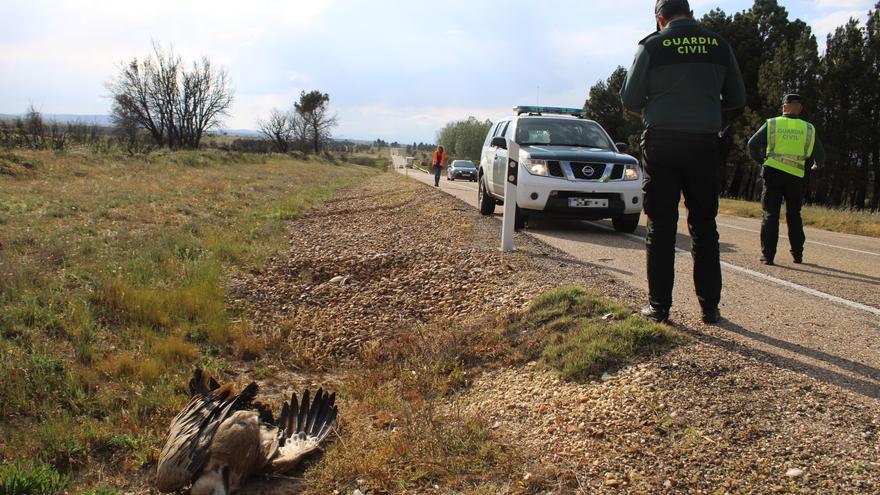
left=304, top=287, right=687, bottom=494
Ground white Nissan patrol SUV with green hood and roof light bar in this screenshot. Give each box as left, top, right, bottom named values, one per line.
left=477, top=107, right=643, bottom=232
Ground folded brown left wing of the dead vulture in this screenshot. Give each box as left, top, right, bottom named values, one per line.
left=156, top=369, right=257, bottom=492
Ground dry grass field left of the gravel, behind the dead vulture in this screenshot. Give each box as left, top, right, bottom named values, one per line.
left=0, top=147, right=375, bottom=492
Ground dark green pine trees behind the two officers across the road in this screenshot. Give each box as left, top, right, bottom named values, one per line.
left=585, top=0, right=880, bottom=211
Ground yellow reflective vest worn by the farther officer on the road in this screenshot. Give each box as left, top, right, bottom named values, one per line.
left=764, top=116, right=816, bottom=178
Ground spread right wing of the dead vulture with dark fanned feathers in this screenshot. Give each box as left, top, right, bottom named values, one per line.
left=268, top=389, right=338, bottom=473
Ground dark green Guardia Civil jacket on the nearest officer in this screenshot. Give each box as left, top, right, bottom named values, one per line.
left=620, top=19, right=746, bottom=133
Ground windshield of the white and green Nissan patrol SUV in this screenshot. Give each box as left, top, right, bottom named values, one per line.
left=516, top=118, right=614, bottom=150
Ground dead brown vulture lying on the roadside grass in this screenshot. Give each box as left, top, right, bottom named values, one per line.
left=156, top=369, right=337, bottom=495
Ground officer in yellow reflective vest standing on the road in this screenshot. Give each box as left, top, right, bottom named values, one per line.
left=749, top=94, right=825, bottom=265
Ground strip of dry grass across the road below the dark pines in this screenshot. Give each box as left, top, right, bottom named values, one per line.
left=719, top=199, right=880, bottom=237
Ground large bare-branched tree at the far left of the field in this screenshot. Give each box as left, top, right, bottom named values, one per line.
left=107, top=44, right=233, bottom=148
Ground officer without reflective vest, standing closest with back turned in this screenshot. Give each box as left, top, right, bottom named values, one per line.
left=620, top=0, right=746, bottom=323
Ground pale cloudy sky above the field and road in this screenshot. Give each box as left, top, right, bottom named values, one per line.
left=0, top=0, right=874, bottom=142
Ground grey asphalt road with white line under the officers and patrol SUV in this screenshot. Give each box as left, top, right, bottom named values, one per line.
left=393, top=155, right=880, bottom=400
